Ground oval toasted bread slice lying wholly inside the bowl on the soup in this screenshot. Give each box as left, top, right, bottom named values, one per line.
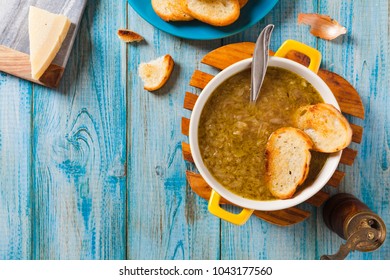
left=265, top=127, right=313, bottom=199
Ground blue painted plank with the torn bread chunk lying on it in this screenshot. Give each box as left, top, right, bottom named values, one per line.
left=127, top=4, right=220, bottom=259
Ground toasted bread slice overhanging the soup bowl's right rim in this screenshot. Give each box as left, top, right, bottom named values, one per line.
left=295, top=103, right=352, bottom=153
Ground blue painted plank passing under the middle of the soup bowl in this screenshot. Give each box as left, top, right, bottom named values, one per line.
left=221, top=0, right=317, bottom=260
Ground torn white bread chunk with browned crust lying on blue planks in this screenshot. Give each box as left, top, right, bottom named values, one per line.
left=138, top=54, right=174, bottom=91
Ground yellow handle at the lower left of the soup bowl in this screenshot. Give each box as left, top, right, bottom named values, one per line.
left=209, top=190, right=254, bottom=226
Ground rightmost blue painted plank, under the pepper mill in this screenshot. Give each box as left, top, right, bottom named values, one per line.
left=317, top=0, right=390, bottom=260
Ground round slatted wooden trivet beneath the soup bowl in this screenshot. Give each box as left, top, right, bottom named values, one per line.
left=181, top=42, right=364, bottom=226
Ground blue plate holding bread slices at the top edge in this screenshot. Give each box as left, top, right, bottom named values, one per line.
left=128, top=0, right=278, bottom=40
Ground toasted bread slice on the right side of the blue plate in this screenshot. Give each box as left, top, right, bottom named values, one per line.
left=181, top=0, right=240, bottom=26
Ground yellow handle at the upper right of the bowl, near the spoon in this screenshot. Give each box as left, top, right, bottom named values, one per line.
left=275, top=40, right=321, bottom=73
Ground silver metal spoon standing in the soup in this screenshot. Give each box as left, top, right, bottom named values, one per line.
left=250, top=24, right=274, bottom=103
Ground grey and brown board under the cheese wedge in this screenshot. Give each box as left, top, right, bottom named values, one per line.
left=0, top=0, right=87, bottom=88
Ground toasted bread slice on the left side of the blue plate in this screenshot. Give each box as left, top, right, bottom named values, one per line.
left=152, top=0, right=194, bottom=21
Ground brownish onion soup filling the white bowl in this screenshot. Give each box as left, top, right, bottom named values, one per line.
left=198, top=67, right=327, bottom=200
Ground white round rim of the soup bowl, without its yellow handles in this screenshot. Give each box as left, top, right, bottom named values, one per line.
left=189, top=57, right=341, bottom=211
